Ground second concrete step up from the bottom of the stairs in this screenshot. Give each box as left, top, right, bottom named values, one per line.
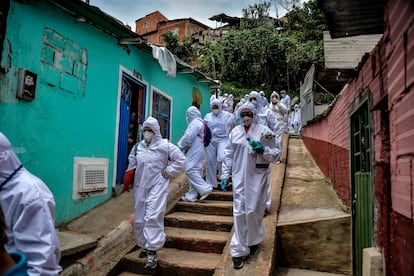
left=165, top=227, right=230, bottom=254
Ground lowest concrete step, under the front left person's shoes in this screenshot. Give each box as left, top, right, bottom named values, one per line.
left=122, top=248, right=221, bottom=276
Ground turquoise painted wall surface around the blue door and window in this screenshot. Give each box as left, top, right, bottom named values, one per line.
left=0, top=1, right=210, bottom=224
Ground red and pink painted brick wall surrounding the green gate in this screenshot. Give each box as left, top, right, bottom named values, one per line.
left=304, top=0, right=414, bottom=276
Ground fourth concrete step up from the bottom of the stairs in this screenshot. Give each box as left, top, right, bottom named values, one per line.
left=175, top=198, right=233, bottom=216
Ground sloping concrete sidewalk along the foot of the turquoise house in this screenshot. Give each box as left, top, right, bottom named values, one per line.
left=58, top=173, right=188, bottom=275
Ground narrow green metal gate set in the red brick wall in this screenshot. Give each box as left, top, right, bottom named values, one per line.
left=351, top=101, right=373, bottom=275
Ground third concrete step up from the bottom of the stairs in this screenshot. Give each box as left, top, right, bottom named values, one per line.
left=164, top=212, right=233, bottom=232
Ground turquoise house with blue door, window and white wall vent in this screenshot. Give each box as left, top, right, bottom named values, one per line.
left=0, top=0, right=216, bottom=224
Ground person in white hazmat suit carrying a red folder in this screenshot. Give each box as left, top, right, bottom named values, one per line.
left=128, top=116, right=185, bottom=269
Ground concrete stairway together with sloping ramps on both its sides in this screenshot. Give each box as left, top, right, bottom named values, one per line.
left=58, top=135, right=351, bottom=276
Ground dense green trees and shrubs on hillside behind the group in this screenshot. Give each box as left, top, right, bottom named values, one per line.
left=175, top=0, right=327, bottom=99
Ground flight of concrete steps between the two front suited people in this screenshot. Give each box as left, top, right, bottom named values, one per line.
left=118, top=191, right=233, bottom=276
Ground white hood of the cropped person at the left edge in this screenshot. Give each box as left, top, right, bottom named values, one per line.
left=0, top=132, right=22, bottom=186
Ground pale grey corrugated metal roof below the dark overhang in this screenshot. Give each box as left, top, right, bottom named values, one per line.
left=323, top=32, right=382, bottom=70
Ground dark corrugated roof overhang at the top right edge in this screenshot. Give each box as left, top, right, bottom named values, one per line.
left=318, top=0, right=388, bottom=38
